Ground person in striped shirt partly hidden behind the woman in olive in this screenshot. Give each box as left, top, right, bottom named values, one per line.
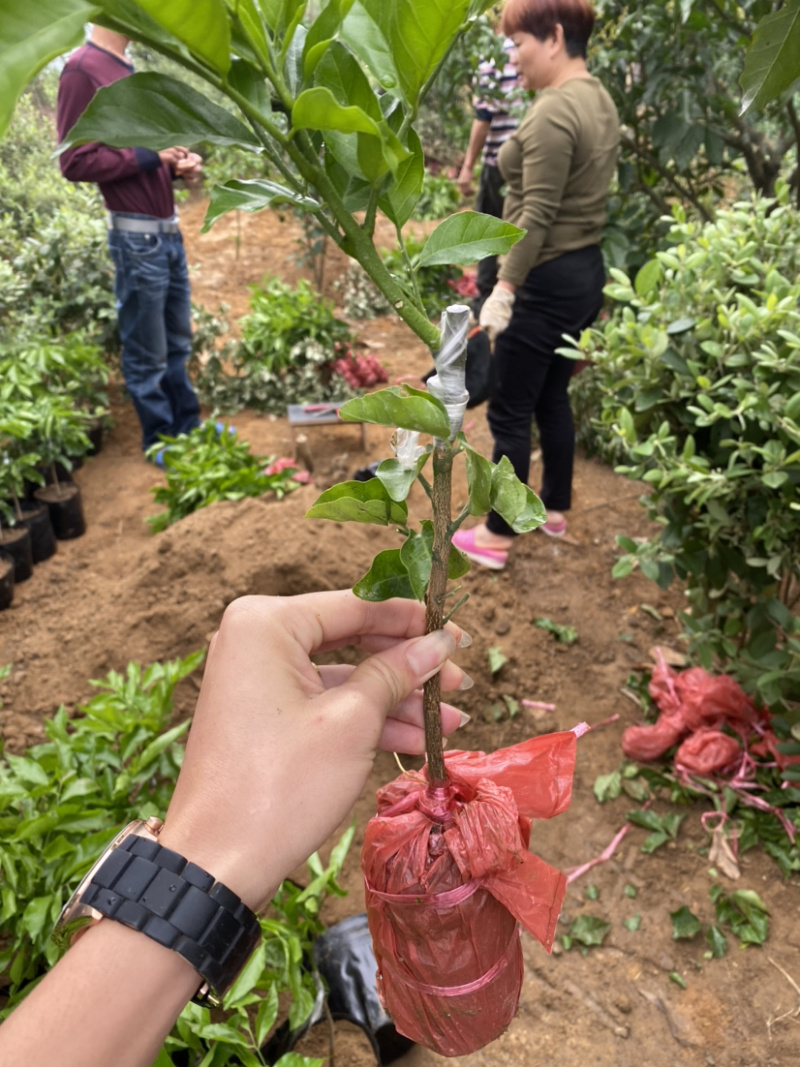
left=455, top=37, right=523, bottom=317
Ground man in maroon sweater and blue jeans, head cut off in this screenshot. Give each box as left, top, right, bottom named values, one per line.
left=57, top=26, right=202, bottom=454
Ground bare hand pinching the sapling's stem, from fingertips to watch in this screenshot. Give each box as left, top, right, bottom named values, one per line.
left=160, top=591, right=468, bottom=909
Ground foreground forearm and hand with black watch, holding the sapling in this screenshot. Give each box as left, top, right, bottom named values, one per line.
left=0, top=590, right=471, bottom=1067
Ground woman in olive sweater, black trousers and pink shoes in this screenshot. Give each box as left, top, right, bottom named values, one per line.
left=453, top=0, right=620, bottom=570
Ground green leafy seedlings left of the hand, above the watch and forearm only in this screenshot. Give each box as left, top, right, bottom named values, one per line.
left=0, top=653, right=204, bottom=1004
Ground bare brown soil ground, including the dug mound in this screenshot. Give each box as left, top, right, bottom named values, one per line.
left=0, top=202, right=800, bottom=1067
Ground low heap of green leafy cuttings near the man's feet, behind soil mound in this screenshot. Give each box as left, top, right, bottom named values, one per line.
left=147, top=420, right=300, bottom=534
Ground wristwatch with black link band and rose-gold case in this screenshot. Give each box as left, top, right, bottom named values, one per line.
left=52, top=817, right=261, bottom=1005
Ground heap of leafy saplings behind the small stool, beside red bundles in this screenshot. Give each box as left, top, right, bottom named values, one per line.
left=195, top=277, right=354, bottom=415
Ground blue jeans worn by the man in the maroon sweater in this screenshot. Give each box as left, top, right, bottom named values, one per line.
left=109, top=213, right=201, bottom=449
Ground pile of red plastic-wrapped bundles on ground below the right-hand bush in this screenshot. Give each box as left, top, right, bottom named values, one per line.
left=622, top=658, right=798, bottom=776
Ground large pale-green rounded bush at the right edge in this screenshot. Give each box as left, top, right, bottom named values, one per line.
left=572, top=190, right=800, bottom=714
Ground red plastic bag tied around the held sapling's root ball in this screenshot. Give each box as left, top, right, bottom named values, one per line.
left=362, top=731, right=576, bottom=1056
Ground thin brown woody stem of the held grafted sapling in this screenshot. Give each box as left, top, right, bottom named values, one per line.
left=422, top=439, right=453, bottom=787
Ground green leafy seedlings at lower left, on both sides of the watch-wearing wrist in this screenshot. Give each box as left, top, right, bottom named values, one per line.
left=0, top=652, right=354, bottom=1067
